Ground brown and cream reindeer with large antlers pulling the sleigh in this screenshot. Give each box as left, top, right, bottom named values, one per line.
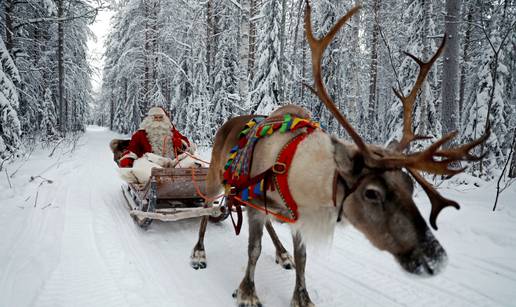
left=192, top=1, right=489, bottom=307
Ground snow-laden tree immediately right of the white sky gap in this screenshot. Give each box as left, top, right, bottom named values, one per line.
left=101, top=0, right=158, bottom=132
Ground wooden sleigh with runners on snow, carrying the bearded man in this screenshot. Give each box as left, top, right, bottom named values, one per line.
left=112, top=140, right=229, bottom=228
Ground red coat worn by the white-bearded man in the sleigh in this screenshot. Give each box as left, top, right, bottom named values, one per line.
left=120, top=126, right=190, bottom=167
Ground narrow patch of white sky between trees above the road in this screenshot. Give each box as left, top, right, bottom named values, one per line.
left=88, top=9, right=114, bottom=92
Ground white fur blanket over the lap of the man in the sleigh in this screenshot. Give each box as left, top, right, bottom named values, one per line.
left=118, top=153, right=208, bottom=183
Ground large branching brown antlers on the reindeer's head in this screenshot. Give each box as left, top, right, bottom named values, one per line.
left=305, top=0, right=490, bottom=230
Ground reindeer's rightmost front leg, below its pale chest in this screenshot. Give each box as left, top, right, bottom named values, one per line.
left=290, top=232, right=315, bottom=307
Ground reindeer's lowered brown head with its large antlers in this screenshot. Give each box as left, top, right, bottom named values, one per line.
left=305, top=0, right=489, bottom=275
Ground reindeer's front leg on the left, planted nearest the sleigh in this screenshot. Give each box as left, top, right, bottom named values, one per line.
left=233, top=209, right=264, bottom=307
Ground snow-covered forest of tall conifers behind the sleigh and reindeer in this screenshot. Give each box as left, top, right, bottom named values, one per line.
left=0, top=0, right=516, bottom=173
